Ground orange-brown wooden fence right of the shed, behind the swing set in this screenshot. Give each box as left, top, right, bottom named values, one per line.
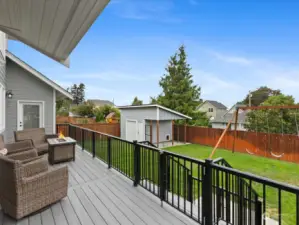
left=174, top=125, right=299, bottom=163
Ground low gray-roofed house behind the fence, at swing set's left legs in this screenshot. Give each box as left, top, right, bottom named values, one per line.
left=211, top=104, right=248, bottom=131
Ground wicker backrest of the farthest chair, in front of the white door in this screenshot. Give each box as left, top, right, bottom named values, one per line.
left=15, top=128, right=46, bottom=145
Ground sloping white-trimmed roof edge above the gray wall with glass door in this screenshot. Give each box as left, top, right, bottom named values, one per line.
left=6, top=51, right=73, bottom=99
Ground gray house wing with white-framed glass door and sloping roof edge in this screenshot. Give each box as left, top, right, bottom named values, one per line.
left=5, top=52, right=72, bottom=142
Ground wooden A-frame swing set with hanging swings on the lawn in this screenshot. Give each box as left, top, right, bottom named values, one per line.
left=209, top=105, right=299, bottom=159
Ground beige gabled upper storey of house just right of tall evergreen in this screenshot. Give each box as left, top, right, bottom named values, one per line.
left=198, top=100, right=227, bottom=121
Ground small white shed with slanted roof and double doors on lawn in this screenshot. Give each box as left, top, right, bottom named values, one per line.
left=118, top=104, right=192, bottom=147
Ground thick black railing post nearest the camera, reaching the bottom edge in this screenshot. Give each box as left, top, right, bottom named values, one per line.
left=202, top=159, right=213, bottom=225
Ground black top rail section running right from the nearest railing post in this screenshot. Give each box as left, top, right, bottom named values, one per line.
left=212, top=163, right=299, bottom=194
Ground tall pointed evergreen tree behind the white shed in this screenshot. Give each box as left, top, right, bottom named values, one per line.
left=157, top=45, right=209, bottom=126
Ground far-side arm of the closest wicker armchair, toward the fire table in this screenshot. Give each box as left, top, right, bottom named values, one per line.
left=23, top=158, right=48, bottom=177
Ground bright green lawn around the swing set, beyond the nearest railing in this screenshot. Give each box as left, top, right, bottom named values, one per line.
left=166, top=144, right=299, bottom=224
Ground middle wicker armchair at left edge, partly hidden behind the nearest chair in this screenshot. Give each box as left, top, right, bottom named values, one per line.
left=0, top=135, right=34, bottom=155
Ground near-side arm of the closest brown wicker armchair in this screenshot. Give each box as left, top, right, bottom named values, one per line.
left=22, top=166, right=68, bottom=185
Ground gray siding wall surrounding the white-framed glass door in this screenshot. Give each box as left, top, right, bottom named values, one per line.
left=6, top=60, right=54, bottom=142
